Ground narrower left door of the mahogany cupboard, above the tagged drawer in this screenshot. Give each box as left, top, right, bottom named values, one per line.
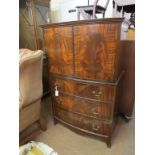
left=44, top=27, right=73, bottom=75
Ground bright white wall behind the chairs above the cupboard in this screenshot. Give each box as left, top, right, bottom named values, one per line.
left=50, top=0, right=113, bottom=22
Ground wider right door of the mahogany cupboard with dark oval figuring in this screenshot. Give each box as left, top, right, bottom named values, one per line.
left=74, top=23, right=120, bottom=80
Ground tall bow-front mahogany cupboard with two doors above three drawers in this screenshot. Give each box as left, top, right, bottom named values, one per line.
left=42, top=18, right=134, bottom=147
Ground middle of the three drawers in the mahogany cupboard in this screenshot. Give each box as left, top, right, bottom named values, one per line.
left=53, top=93, right=112, bottom=120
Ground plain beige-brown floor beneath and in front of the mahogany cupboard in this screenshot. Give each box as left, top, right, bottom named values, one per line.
left=35, top=97, right=135, bottom=155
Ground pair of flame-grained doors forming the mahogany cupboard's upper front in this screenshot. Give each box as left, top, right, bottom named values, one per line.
left=44, top=22, right=121, bottom=82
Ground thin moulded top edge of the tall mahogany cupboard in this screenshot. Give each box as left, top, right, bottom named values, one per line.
left=41, top=18, right=129, bottom=28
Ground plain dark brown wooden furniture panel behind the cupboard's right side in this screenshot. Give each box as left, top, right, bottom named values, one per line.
left=119, top=41, right=135, bottom=117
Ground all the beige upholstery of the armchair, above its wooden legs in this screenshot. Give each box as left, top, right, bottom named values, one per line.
left=19, top=49, right=43, bottom=132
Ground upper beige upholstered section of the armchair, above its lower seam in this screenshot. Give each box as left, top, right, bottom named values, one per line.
left=19, top=49, right=43, bottom=110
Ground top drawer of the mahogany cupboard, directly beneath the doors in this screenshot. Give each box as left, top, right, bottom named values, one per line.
left=50, top=78, right=115, bottom=102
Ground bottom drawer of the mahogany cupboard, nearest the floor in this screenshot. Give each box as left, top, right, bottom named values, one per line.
left=55, top=108, right=112, bottom=135
